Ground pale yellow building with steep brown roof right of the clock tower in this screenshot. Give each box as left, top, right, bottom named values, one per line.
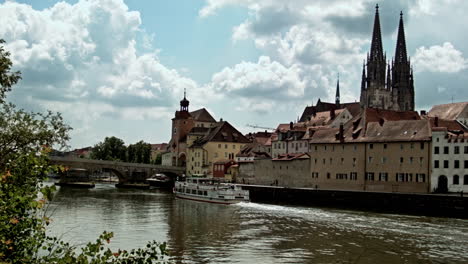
left=187, top=121, right=249, bottom=176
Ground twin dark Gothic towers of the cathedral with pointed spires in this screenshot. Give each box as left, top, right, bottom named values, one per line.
left=360, top=5, right=414, bottom=111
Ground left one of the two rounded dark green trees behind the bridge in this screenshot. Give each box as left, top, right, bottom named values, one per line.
left=91, top=137, right=127, bottom=161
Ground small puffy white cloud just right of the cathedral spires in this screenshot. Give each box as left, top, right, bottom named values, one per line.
left=413, top=42, right=468, bottom=73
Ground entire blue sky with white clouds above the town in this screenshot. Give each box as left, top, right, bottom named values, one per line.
left=0, top=0, right=468, bottom=148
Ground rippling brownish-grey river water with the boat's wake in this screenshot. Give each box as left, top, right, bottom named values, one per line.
left=47, top=184, right=468, bottom=264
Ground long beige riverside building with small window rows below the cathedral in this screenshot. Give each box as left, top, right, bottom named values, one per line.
left=310, top=108, right=431, bottom=193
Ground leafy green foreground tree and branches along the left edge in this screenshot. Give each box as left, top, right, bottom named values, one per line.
left=0, top=40, right=166, bottom=264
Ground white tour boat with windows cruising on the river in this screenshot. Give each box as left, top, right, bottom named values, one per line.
left=174, top=178, right=249, bottom=204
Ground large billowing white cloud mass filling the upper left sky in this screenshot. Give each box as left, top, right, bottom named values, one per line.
left=0, top=0, right=205, bottom=117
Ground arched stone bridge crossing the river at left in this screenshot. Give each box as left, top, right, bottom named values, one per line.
left=50, top=156, right=185, bottom=183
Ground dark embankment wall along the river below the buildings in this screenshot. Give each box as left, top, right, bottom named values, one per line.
left=242, top=185, right=468, bottom=219
